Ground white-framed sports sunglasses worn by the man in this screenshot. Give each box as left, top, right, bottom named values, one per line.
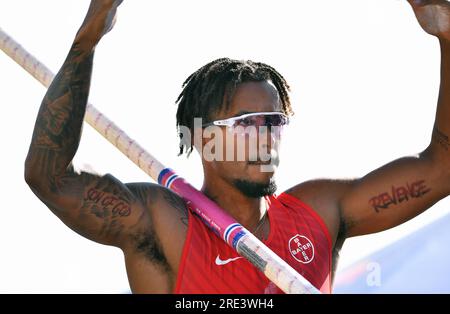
left=202, top=112, right=289, bottom=129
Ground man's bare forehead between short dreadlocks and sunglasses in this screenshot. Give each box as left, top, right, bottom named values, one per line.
left=218, top=81, right=281, bottom=118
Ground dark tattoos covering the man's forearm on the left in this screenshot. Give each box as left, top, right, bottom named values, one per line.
left=26, top=43, right=94, bottom=182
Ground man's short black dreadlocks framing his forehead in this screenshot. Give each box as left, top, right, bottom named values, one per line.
left=176, top=58, right=293, bottom=156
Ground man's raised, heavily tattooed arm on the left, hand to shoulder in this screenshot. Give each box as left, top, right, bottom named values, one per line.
left=25, top=0, right=155, bottom=246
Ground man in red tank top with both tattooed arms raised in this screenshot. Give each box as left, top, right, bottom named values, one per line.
left=25, top=0, right=450, bottom=293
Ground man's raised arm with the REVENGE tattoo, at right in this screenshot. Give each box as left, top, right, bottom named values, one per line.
left=338, top=0, right=450, bottom=237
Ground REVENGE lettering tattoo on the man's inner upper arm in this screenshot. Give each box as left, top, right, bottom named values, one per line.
left=369, top=180, right=431, bottom=213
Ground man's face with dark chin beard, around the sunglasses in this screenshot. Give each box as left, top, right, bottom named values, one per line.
left=202, top=81, right=282, bottom=196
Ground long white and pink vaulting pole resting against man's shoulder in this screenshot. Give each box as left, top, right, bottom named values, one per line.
left=0, top=28, right=320, bottom=294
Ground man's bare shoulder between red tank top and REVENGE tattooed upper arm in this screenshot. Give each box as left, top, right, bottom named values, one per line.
left=284, top=179, right=354, bottom=245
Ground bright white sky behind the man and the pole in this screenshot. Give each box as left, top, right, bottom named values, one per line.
left=0, top=0, right=450, bottom=293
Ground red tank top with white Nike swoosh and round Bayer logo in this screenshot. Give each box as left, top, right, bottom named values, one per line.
left=174, top=193, right=331, bottom=294
